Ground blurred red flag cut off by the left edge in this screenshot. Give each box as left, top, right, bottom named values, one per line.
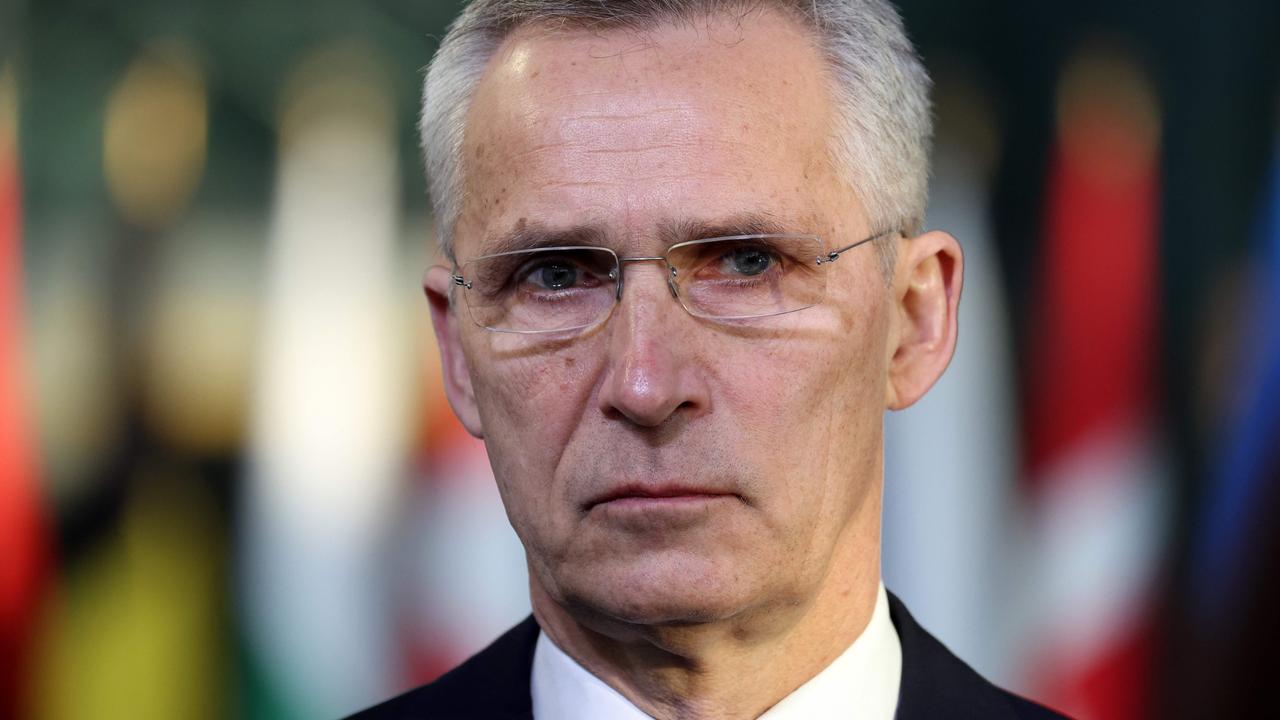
left=0, top=60, right=50, bottom=717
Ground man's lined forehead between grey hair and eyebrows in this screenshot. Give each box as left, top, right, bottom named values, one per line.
left=456, top=12, right=835, bottom=254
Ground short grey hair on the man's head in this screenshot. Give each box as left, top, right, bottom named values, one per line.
left=419, top=0, right=932, bottom=266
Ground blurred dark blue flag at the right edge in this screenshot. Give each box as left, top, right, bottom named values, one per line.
left=1174, top=144, right=1280, bottom=717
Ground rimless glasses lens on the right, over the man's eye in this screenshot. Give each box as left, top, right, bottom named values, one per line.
left=667, top=236, right=826, bottom=319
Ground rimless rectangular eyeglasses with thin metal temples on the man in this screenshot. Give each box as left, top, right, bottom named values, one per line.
left=452, top=232, right=890, bottom=334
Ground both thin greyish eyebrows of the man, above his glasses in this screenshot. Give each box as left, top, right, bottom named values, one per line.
left=480, top=213, right=806, bottom=255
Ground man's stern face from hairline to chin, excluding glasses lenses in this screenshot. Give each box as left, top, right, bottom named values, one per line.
left=438, top=13, right=891, bottom=623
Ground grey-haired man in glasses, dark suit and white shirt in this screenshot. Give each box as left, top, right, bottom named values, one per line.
left=361, top=0, right=1052, bottom=720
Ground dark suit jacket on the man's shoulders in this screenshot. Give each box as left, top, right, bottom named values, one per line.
left=351, top=593, right=1061, bottom=720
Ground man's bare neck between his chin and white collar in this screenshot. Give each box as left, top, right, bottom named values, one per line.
left=530, top=502, right=879, bottom=720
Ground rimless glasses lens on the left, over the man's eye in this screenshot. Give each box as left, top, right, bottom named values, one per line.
left=462, top=242, right=618, bottom=332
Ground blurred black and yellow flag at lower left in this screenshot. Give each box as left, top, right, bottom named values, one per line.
left=32, top=471, right=228, bottom=720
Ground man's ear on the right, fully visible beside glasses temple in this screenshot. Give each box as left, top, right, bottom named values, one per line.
left=884, top=232, right=964, bottom=410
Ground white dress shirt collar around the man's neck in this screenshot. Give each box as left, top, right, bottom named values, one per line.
left=530, top=583, right=902, bottom=720
